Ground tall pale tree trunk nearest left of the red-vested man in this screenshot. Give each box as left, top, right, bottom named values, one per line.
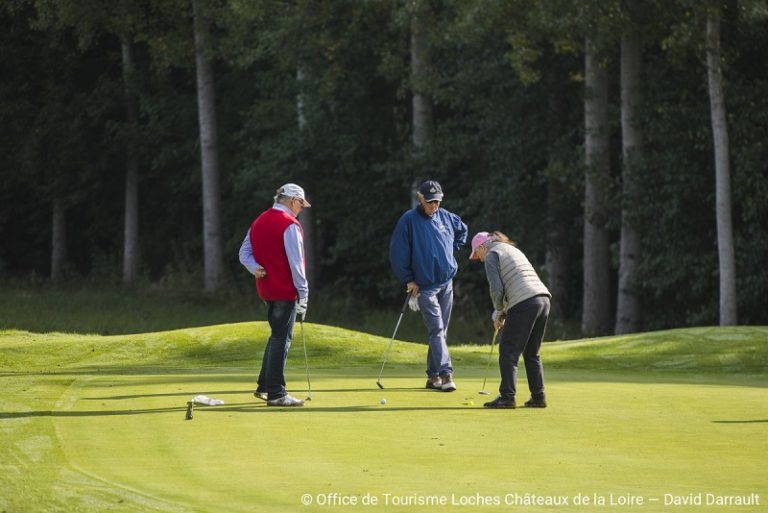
left=192, top=0, right=223, bottom=292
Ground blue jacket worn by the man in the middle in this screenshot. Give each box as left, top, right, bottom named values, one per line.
left=389, top=205, right=467, bottom=290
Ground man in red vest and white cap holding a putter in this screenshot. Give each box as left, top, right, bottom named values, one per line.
left=240, top=183, right=311, bottom=406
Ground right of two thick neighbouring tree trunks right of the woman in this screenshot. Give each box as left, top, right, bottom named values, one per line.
left=615, top=9, right=643, bottom=334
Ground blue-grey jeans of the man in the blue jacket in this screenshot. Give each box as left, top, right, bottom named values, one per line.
left=419, top=281, right=453, bottom=377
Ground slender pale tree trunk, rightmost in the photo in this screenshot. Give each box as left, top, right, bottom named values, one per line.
left=707, top=7, right=737, bottom=326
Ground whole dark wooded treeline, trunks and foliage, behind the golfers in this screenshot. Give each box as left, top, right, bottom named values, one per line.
left=0, top=0, right=768, bottom=335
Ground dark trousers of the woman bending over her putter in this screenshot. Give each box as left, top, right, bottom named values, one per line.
left=499, top=296, right=549, bottom=399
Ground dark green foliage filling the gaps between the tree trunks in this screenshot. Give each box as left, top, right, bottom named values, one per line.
left=0, top=0, right=768, bottom=332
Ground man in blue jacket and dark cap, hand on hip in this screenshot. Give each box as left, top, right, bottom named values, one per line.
left=389, top=180, right=467, bottom=392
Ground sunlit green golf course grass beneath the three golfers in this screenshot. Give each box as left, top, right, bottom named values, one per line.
left=0, top=323, right=768, bottom=513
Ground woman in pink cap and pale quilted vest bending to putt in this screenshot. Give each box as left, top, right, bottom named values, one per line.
left=469, top=232, right=552, bottom=408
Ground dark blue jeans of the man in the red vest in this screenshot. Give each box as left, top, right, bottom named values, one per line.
left=256, top=301, right=296, bottom=400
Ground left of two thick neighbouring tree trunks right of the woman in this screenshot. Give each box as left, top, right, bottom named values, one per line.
left=581, top=38, right=612, bottom=336
